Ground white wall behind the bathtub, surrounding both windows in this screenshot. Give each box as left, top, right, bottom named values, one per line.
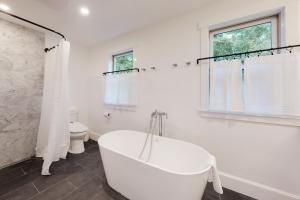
left=87, top=0, right=300, bottom=200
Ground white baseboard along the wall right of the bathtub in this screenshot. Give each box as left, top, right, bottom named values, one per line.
left=219, top=172, right=300, bottom=200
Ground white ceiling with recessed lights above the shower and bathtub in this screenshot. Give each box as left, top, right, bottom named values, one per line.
left=5, top=0, right=215, bottom=46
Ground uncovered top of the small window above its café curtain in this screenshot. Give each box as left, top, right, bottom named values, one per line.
left=112, top=51, right=133, bottom=71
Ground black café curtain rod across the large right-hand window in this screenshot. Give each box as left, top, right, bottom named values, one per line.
left=197, top=44, right=300, bottom=64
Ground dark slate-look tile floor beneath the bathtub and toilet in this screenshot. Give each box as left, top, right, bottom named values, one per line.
left=0, top=141, right=254, bottom=200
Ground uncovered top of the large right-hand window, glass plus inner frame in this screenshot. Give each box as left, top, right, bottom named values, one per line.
left=210, top=16, right=278, bottom=60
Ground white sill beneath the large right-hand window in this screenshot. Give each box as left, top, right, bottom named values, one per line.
left=198, top=109, right=300, bottom=126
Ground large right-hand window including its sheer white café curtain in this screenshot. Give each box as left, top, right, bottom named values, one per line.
left=209, top=16, right=286, bottom=115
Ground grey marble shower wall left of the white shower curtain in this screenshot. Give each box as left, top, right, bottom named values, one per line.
left=0, top=19, right=45, bottom=168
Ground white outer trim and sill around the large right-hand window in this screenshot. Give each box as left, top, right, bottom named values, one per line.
left=198, top=11, right=300, bottom=126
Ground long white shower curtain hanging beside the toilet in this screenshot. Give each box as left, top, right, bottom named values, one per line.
left=36, top=40, right=70, bottom=175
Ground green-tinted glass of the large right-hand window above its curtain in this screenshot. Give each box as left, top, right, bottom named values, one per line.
left=213, top=22, right=272, bottom=59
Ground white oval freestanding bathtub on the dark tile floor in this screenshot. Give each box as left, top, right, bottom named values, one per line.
left=98, top=130, right=211, bottom=200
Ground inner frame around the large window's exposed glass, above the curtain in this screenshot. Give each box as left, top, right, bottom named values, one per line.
left=209, top=15, right=281, bottom=56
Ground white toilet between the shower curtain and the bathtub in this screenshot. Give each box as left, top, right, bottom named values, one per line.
left=69, top=110, right=88, bottom=154
